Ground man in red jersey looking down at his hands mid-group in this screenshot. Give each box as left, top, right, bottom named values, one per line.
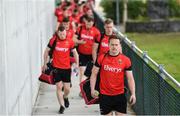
left=74, top=16, right=101, bottom=91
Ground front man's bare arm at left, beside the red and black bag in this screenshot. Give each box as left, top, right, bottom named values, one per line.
left=90, top=65, right=99, bottom=98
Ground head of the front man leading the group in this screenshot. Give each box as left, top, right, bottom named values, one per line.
left=109, top=35, right=122, bottom=56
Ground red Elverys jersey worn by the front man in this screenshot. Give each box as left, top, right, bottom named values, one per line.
left=95, top=53, right=131, bottom=96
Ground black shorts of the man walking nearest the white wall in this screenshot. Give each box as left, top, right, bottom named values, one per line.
left=53, top=68, right=71, bottom=83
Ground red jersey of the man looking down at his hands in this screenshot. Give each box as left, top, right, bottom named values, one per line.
left=76, top=26, right=101, bottom=55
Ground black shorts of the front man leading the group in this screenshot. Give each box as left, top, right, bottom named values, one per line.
left=99, top=94, right=127, bottom=115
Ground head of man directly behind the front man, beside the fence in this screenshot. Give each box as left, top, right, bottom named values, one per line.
left=104, top=18, right=114, bottom=35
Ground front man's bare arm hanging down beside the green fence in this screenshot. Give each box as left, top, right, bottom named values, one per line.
left=126, top=71, right=136, bottom=105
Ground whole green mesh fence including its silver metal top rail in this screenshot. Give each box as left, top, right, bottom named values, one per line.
left=94, top=8, right=180, bottom=115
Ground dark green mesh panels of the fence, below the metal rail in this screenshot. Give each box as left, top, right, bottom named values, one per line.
left=95, top=13, right=180, bottom=115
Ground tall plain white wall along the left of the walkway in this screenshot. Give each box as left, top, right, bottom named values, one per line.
left=0, top=0, right=55, bottom=115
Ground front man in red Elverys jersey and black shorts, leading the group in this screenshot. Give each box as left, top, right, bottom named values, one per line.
left=90, top=35, right=136, bottom=115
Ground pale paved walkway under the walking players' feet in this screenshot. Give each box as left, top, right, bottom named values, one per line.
left=33, top=77, right=134, bottom=115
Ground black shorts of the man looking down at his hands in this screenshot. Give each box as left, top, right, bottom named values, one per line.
left=79, top=53, right=93, bottom=66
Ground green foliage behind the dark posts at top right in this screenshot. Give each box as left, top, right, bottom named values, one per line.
left=101, top=0, right=180, bottom=22
